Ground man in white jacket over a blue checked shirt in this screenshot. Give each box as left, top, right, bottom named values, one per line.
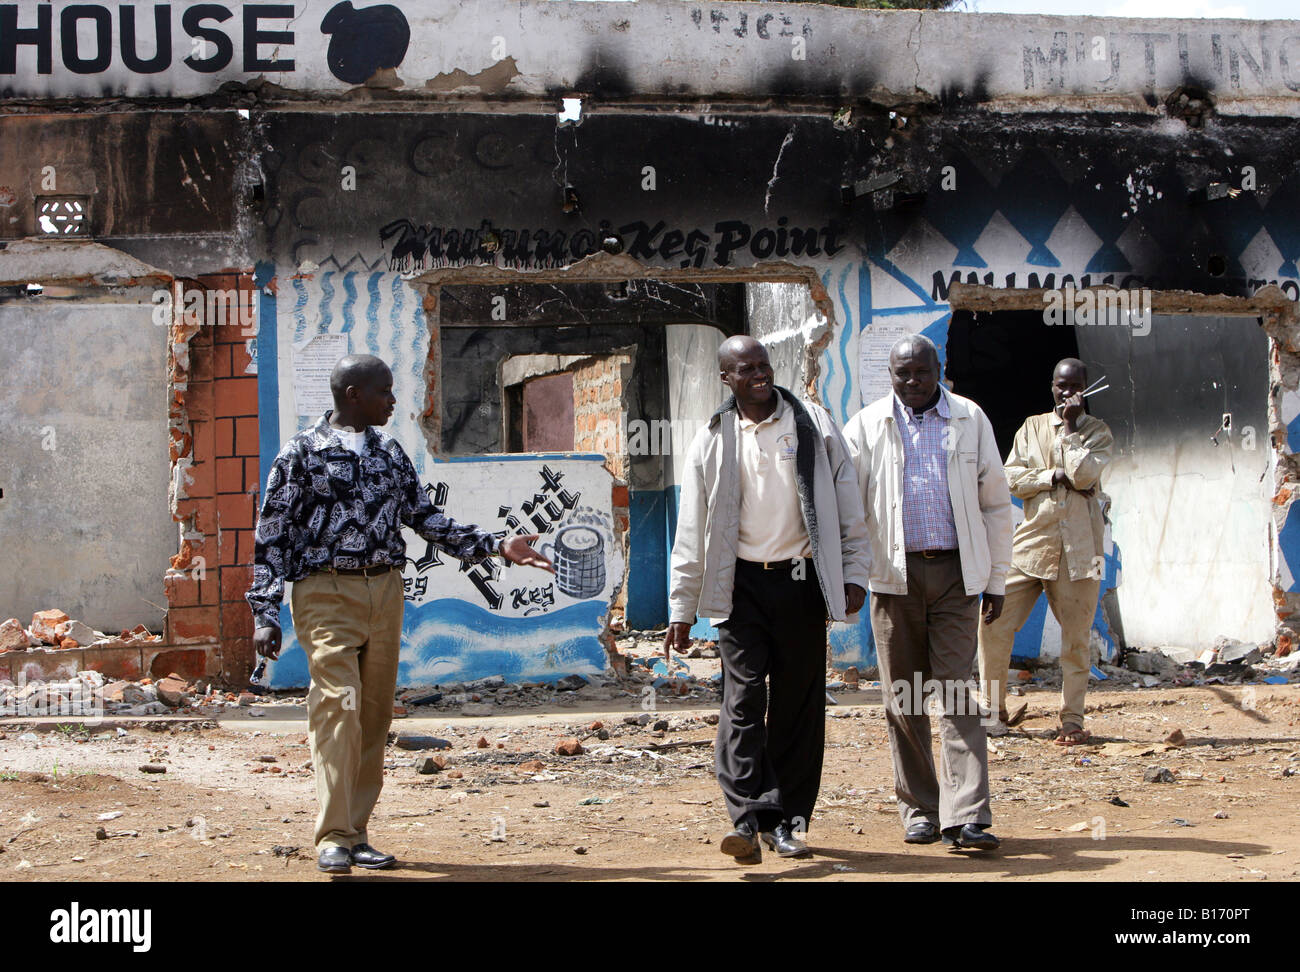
left=845, top=335, right=1011, bottom=850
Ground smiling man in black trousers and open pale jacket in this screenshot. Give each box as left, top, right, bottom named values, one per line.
left=663, top=335, right=871, bottom=864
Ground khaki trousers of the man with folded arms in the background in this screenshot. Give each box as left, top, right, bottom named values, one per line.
left=979, top=556, right=1101, bottom=729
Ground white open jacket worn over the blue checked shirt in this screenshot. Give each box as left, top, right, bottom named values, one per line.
left=844, top=385, right=1011, bottom=595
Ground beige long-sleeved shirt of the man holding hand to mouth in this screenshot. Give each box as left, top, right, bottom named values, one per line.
left=1006, top=412, right=1114, bottom=581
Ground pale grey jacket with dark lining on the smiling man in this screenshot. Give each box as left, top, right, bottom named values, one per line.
left=668, top=386, right=871, bottom=622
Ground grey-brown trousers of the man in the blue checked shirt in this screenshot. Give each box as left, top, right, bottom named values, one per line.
left=871, top=551, right=993, bottom=828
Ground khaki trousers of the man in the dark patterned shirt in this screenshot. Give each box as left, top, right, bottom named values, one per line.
left=290, top=570, right=406, bottom=851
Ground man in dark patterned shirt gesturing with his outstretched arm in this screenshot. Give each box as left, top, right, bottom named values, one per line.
left=246, top=355, right=554, bottom=873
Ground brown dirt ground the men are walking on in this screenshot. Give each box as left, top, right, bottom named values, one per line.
left=0, top=685, right=1300, bottom=882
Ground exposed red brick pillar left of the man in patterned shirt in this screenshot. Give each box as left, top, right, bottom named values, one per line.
left=161, top=273, right=260, bottom=685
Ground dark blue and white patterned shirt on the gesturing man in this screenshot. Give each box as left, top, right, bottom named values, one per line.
left=244, top=412, right=501, bottom=628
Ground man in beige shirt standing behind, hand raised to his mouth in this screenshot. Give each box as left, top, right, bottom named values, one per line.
left=979, top=357, right=1113, bottom=746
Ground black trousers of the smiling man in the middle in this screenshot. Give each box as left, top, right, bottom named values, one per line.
left=714, top=560, right=827, bottom=830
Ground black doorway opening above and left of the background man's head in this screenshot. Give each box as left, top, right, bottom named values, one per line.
left=945, top=311, right=1092, bottom=459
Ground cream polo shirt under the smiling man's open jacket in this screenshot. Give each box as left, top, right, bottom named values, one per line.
left=736, top=392, right=813, bottom=561
